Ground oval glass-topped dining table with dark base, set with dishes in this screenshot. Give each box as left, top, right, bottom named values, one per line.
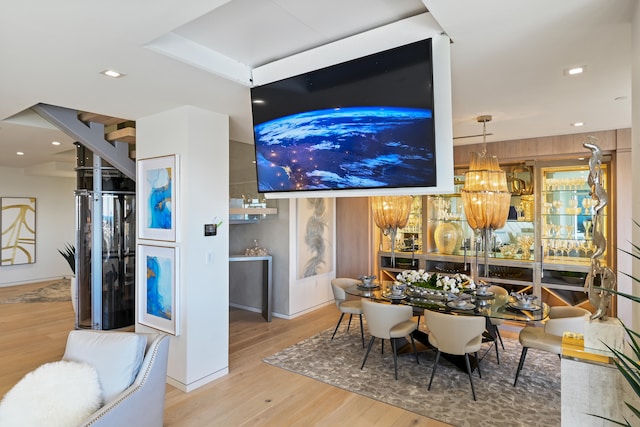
left=345, top=281, right=550, bottom=369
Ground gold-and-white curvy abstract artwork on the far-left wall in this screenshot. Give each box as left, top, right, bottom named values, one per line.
left=0, top=197, right=36, bottom=265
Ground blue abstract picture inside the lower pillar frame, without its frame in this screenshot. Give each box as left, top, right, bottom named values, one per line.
left=146, top=256, right=173, bottom=320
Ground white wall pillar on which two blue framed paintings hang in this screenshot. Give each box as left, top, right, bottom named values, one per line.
left=136, top=106, right=229, bottom=392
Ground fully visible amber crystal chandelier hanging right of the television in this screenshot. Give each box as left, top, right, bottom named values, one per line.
left=462, top=115, right=511, bottom=276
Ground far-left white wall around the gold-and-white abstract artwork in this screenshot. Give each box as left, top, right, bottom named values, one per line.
left=0, top=168, right=76, bottom=287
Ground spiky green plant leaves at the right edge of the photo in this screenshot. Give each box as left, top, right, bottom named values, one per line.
left=591, top=221, right=640, bottom=427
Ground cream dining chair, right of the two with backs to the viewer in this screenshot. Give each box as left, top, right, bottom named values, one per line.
left=424, top=310, right=486, bottom=400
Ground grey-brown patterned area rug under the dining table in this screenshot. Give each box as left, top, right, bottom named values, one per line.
left=263, top=328, right=560, bottom=427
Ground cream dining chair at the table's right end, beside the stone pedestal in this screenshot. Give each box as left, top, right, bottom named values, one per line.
left=513, top=307, right=591, bottom=387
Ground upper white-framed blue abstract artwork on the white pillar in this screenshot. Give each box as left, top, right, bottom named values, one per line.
left=137, top=154, right=178, bottom=242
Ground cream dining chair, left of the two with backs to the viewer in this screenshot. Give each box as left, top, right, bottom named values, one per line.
left=360, top=300, right=420, bottom=380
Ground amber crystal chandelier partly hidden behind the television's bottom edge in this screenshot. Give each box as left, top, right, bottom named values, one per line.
left=371, top=196, right=413, bottom=267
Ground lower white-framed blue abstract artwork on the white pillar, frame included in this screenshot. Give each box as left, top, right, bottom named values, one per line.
left=138, top=245, right=179, bottom=335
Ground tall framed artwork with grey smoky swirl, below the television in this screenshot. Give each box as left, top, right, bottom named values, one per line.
left=296, top=198, right=333, bottom=279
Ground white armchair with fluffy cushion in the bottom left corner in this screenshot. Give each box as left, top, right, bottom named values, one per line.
left=0, top=330, right=169, bottom=427
